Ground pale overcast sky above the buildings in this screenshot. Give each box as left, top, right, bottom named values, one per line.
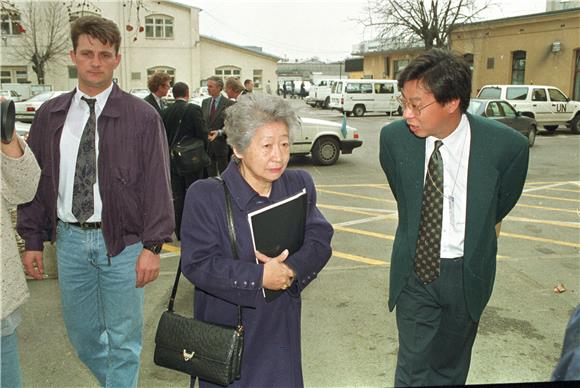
left=177, top=0, right=546, bottom=60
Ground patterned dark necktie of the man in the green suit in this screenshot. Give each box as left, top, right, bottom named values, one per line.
left=415, top=140, right=443, bottom=284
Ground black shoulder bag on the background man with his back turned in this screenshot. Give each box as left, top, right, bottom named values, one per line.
left=169, top=105, right=210, bottom=176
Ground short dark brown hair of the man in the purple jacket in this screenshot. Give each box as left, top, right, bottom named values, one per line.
left=70, top=16, right=121, bottom=54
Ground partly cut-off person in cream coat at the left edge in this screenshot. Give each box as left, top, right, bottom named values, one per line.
left=0, top=104, right=43, bottom=388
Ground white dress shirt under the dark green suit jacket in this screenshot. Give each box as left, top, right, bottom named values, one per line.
left=425, top=114, right=471, bottom=259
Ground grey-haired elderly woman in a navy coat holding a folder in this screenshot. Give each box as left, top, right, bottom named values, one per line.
left=181, top=94, right=333, bottom=387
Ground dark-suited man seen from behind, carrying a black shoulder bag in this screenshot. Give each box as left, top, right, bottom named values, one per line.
left=161, top=82, right=207, bottom=240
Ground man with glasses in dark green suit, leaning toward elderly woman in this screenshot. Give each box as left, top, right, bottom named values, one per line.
left=380, top=49, right=529, bottom=386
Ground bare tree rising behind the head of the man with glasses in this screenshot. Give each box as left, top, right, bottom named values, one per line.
left=357, top=0, right=491, bottom=49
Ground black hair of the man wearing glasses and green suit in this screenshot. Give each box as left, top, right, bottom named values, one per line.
left=397, top=48, right=471, bottom=113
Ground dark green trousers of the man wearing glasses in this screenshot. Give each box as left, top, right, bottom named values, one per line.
left=395, top=258, right=479, bottom=386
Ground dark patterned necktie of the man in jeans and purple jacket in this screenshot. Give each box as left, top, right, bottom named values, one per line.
left=72, top=97, right=97, bottom=223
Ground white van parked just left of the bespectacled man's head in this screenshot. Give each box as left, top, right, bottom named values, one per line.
left=330, top=79, right=403, bottom=117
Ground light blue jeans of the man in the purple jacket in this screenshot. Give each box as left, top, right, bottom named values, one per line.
left=56, top=221, right=143, bottom=387
